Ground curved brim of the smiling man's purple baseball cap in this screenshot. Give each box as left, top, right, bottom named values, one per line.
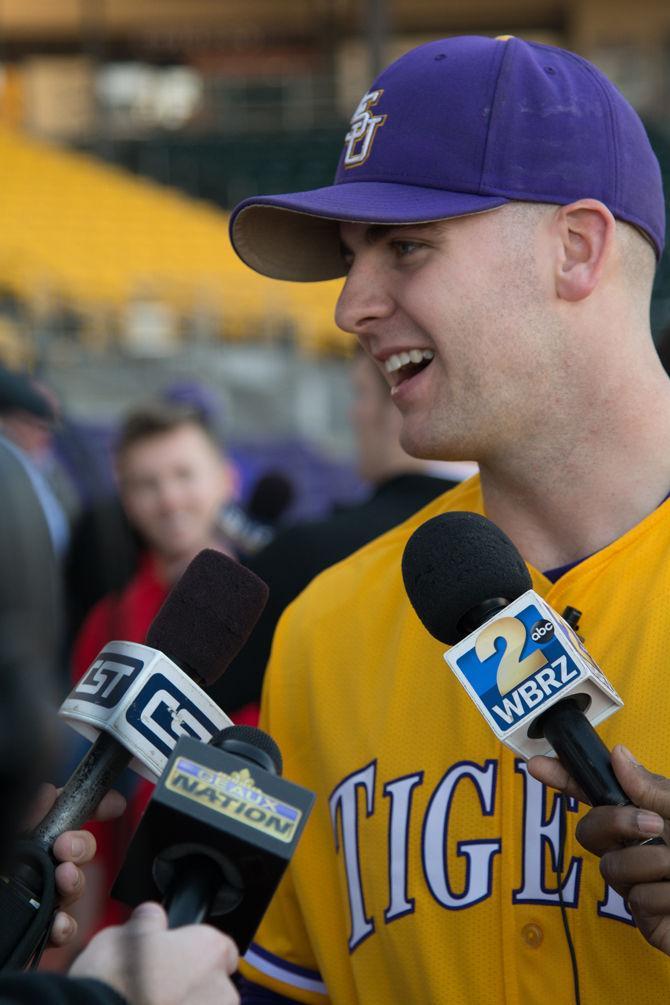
left=230, top=182, right=509, bottom=282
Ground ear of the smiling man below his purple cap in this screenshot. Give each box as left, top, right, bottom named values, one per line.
left=553, top=199, right=616, bottom=302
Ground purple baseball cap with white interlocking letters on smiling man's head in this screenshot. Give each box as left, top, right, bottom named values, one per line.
left=230, top=36, right=665, bottom=281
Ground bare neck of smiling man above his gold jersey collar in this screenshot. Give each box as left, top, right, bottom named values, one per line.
left=480, top=377, right=670, bottom=570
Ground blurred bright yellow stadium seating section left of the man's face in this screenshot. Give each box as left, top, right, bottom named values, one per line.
left=0, top=131, right=349, bottom=351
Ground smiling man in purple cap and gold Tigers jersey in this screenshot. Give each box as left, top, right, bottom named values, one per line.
left=231, top=38, right=670, bottom=1005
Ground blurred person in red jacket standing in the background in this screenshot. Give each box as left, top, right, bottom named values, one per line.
left=72, top=402, right=242, bottom=935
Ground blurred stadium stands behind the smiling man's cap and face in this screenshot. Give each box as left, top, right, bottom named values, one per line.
left=0, top=0, right=670, bottom=517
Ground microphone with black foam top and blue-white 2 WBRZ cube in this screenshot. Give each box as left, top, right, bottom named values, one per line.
left=402, top=513, right=630, bottom=806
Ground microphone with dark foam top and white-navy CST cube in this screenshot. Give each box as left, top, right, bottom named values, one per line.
left=0, top=550, right=267, bottom=968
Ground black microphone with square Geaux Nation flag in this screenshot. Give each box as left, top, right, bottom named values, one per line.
left=111, top=726, right=314, bottom=954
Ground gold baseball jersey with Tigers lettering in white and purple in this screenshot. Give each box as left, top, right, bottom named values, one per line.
left=242, top=478, right=670, bottom=1005
